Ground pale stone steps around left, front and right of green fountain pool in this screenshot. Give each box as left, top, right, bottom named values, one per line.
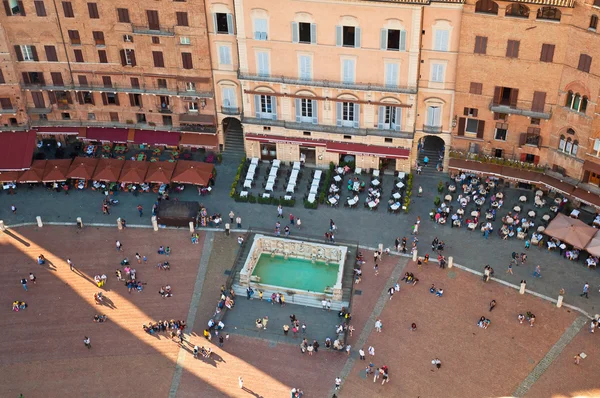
left=227, top=233, right=356, bottom=311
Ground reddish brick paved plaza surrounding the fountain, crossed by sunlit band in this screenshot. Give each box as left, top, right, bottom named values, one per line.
left=0, top=226, right=599, bottom=398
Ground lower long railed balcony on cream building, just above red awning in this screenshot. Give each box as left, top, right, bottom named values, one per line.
left=242, top=115, right=414, bottom=139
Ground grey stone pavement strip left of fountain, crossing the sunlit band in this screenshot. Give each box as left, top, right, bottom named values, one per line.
left=169, top=232, right=214, bottom=398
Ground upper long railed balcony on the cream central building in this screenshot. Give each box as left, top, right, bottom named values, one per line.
left=238, top=71, right=417, bottom=94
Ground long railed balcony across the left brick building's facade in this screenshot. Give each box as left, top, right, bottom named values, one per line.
left=21, top=82, right=214, bottom=98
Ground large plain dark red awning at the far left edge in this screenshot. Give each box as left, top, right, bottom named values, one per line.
left=0, top=130, right=35, bottom=171
